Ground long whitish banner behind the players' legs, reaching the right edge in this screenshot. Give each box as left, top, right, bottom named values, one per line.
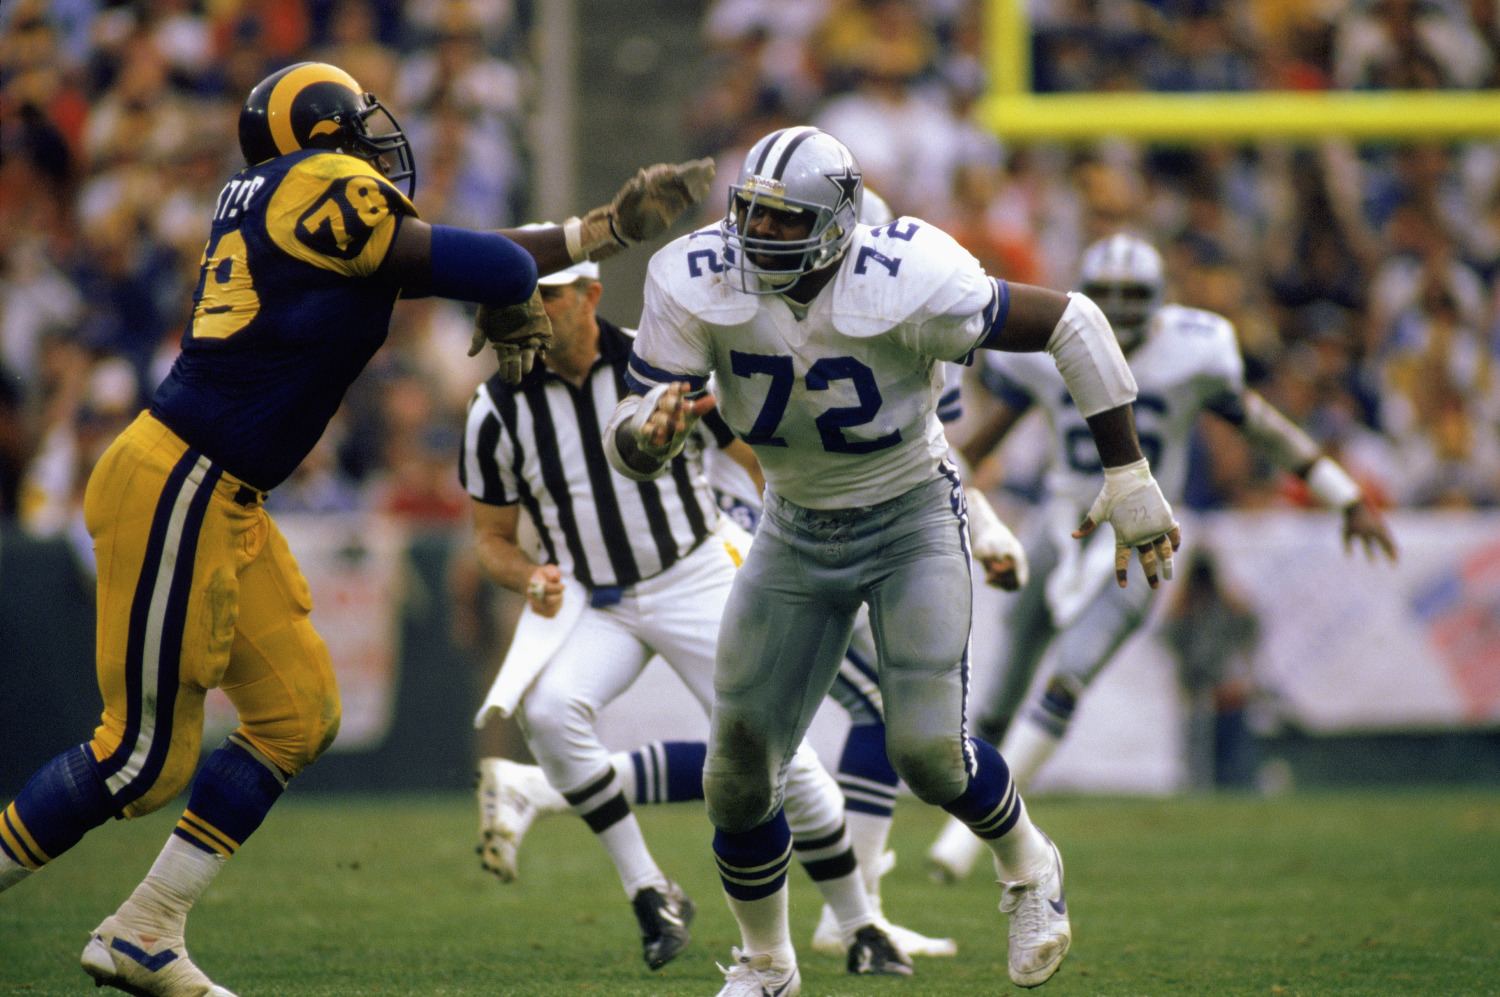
left=600, top=511, right=1500, bottom=793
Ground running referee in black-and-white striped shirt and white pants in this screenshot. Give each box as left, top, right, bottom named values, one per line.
left=459, top=253, right=911, bottom=973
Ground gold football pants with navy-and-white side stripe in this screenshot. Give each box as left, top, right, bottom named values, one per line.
left=84, top=412, right=339, bottom=817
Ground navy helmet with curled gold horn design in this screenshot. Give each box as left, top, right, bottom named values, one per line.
left=240, top=63, right=417, bottom=198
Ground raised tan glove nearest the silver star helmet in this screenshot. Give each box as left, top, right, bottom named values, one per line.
left=563, top=159, right=714, bottom=261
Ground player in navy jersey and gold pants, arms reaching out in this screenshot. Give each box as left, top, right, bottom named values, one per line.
left=0, top=63, right=713, bottom=996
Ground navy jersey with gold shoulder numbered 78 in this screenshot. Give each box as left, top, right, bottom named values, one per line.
left=152, top=150, right=416, bottom=490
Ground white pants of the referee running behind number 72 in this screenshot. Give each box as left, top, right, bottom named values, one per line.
left=518, top=535, right=843, bottom=837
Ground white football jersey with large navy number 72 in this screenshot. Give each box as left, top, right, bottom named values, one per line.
left=630, top=217, right=1010, bottom=508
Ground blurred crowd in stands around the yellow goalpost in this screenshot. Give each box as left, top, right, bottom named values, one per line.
left=687, top=0, right=1500, bottom=508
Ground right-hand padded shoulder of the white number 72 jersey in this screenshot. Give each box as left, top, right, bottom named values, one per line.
left=833, top=214, right=987, bottom=339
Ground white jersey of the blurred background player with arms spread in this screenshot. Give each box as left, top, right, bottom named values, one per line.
left=981, top=304, right=1245, bottom=519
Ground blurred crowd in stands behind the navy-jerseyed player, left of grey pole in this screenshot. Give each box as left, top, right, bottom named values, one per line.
left=0, top=0, right=528, bottom=552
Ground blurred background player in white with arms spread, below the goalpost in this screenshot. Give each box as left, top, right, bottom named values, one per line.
left=927, top=232, right=1397, bottom=880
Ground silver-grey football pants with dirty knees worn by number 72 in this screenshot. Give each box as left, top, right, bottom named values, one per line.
left=704, top=466, right=972, bottom=832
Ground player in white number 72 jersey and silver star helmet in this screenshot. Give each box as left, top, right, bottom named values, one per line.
left=605, top=126, right=1181, bottom=997
